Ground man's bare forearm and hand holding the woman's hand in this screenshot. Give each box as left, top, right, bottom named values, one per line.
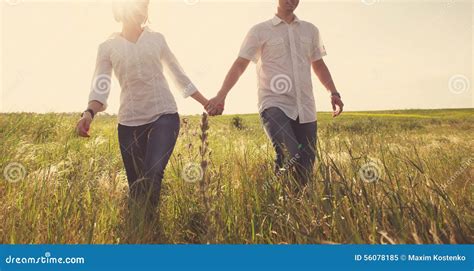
left=206, top=57, right=250, bottom=116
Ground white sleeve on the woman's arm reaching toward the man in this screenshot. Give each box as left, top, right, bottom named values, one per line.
left=161, top=37, right=197, bottom=98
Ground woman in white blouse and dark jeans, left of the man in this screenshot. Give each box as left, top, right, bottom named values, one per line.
left=76, top=0, right=208, bottom=218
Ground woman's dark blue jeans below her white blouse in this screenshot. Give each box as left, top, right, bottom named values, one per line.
left=118, top=113, right=180, bottom=208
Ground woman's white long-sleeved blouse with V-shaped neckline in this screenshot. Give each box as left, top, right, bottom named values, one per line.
left=89, top=27, right=197, bottom=126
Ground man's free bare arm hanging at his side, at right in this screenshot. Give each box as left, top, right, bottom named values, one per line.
left=312, top=59, right=344, bottom=117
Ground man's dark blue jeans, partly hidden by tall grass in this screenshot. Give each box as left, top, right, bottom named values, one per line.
left=260, top=107, right=317, bottom=185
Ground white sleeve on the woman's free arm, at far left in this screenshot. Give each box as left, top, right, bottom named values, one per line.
left=89, top=43, right=112, bottom=110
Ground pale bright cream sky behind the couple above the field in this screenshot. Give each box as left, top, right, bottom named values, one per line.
left=0, top=0, right=474, bottom=114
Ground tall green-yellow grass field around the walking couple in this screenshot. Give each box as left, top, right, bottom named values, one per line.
left=0, top=109, right=474, bottom=244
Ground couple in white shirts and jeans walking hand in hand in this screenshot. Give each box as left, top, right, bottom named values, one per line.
left=76, top=0, right=344, bottom=217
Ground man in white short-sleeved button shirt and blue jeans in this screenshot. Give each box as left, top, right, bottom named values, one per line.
left=206, top=0, right=344, bottom=185
